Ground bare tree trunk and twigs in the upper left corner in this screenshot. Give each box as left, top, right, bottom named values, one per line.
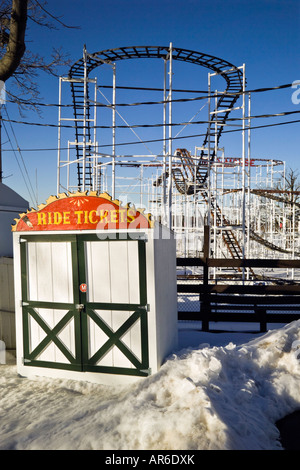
left=0, top=0, right=77, bottom=110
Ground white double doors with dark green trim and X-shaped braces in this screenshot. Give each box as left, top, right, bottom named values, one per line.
left=20, top=234, right=149, bottom=376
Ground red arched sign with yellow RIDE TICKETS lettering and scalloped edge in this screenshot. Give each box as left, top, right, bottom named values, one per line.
left=12, top=191, right=152, bottom=232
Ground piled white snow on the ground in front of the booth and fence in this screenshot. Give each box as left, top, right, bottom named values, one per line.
left=0, top=320, right=300, bottom=451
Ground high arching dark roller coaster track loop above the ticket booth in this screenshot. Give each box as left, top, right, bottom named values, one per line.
left=69, top=46, right=243, bottom=190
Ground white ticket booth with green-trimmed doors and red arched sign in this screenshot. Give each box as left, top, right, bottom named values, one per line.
left=12, top=192, right=177, bottom=384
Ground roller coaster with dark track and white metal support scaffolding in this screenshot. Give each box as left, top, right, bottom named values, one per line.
left=57, top=44, right=300, bottom=274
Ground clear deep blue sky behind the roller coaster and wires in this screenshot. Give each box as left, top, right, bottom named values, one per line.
left=2, top=0, right=300, bottom=205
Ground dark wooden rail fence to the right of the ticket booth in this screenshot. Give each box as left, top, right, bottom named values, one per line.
left=177, top=227, right=300, bottom=331
